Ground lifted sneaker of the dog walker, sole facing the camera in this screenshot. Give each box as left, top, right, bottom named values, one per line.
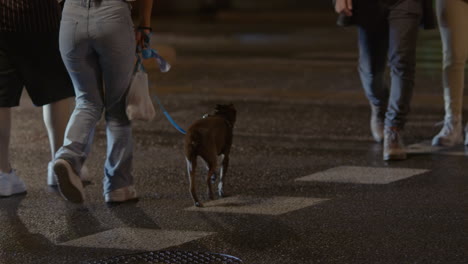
left=54, top=159, right=84, bottom=203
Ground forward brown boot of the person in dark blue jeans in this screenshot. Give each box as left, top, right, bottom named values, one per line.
left=383, top=127, right=406, bottom=161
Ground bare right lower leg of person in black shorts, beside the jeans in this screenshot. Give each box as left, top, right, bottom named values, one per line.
left=42, top=98, right=72, bottom=160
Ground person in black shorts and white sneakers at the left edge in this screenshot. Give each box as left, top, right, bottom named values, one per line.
left=0, top=0, right=75, bottom=196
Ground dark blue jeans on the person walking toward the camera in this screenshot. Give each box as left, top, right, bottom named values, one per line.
left=355, top=0, right=422, bottom=129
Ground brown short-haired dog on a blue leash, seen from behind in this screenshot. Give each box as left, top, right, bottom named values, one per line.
left=184, top=104, right=236, bottom=207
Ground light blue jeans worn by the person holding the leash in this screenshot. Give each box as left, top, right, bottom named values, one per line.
left=56, top=0, right=136, bottom=193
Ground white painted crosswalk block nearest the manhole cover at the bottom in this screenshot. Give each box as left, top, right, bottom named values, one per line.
left=59, top=227, right=215, bottom=251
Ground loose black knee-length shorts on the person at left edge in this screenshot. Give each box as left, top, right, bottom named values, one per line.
left=0, top=32, right=75, bottom=107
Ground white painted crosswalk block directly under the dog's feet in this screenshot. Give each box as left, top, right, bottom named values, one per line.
left=185, top=196, right=328, bottom=215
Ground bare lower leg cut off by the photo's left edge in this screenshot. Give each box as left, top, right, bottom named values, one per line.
left=0, top=107, right=11, bottom=173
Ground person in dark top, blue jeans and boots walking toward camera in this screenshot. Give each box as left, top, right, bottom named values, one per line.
left=335, top=0, right=435, bottom=160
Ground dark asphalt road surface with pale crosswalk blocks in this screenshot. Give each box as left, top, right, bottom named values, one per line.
left=0, top=13, right=468, bottom=264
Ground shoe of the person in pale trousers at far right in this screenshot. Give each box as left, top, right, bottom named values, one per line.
left=432, top=119, right=466, bottom=147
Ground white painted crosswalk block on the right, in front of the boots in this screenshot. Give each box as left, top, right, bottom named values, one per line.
left=296, top=166, right=428, bottom=184
